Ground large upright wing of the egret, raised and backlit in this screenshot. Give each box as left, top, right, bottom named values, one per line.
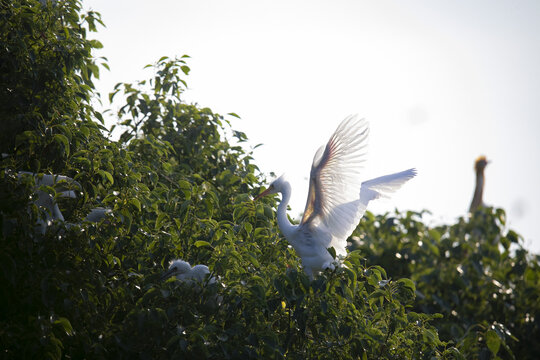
left=300, top=115, right=369, bottom=253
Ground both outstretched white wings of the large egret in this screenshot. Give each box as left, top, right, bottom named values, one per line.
left=300, top=116, right=416, bottom=255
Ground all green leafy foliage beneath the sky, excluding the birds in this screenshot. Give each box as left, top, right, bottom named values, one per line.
left=0, top=0, right=540, bottom=359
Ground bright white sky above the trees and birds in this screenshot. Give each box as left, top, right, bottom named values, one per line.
left=83, top=0, right=540, bottom=252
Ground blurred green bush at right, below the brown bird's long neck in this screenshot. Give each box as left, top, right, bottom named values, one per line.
left=352, top=208, right=540, bottom=359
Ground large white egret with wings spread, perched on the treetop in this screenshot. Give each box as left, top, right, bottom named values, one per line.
left=254, top=115, right=416, bottom=279
